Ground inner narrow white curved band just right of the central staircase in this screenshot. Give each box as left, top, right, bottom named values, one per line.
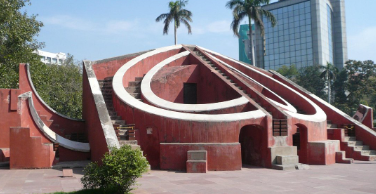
left=207, top=53, right=297, bottom=113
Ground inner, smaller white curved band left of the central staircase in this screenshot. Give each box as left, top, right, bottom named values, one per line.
left=141, top=51, right=249, bottom=112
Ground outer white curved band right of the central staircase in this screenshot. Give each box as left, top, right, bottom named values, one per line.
left=198, top=46, right=326, bottom=122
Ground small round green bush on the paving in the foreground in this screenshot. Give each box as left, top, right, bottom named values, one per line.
left=81, top=145, right=148, bottom=193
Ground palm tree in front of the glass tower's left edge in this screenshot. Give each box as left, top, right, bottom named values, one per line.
left=226, top=0, right=277, bottom=66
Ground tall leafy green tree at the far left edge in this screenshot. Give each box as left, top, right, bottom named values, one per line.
left=0, top=0, right=43, bottom=88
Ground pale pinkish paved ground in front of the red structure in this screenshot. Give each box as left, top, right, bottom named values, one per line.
left=0, top=161, right=376, bottom=194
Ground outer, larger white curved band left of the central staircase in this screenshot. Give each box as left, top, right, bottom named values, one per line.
left=112, top=45, right=266, bottom=122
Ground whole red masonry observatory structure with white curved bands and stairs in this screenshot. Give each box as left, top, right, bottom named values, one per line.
left=0, top=45, right=376, bottom=172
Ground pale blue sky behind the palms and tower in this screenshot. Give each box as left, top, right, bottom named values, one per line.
left=25, top=0, right=376, bottom=61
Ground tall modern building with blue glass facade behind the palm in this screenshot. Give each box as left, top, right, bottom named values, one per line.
left=256, top=0, right=347, bottom=70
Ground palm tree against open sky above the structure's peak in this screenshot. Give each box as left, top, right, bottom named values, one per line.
left=155, top=0, right=192, bottom=45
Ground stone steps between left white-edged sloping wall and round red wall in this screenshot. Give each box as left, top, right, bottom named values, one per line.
left=98, top=77, right=140, bottom=149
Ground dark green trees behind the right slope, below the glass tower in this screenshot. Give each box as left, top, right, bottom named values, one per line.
left=277, top=60, right=376, bottom=119
